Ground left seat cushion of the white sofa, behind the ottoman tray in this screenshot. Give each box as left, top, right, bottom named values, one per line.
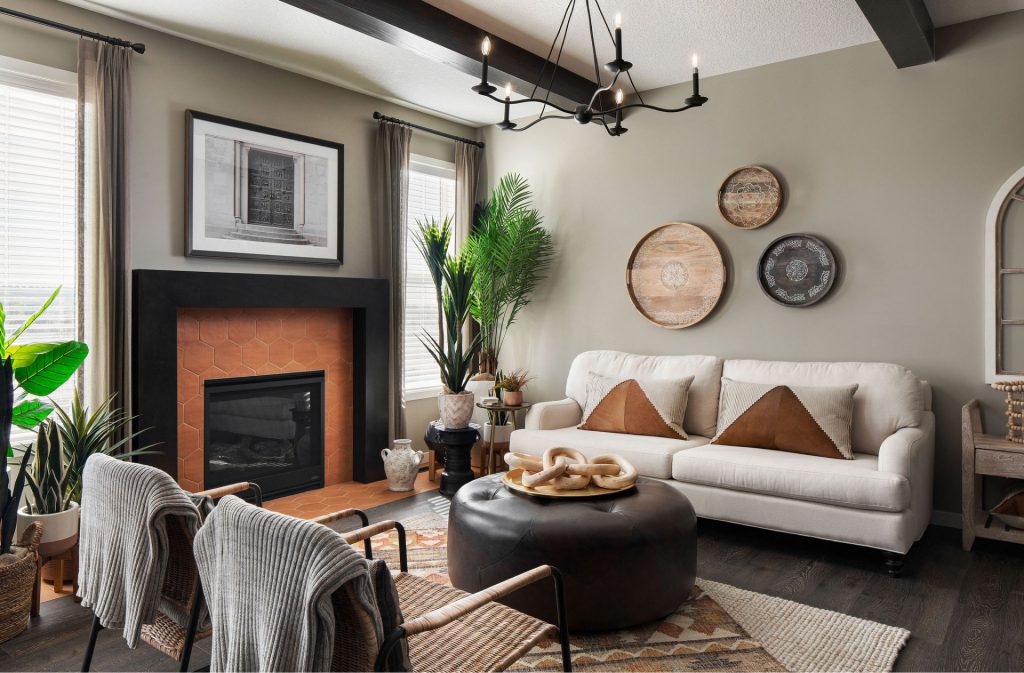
left=509, top=427, right=708, bottom=479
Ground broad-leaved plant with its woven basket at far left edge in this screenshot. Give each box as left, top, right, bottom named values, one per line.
left=0, top=288, right=89, bottom=642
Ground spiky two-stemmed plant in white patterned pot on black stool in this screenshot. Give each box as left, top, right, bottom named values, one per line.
left=417, top=218, right=481, bottom=429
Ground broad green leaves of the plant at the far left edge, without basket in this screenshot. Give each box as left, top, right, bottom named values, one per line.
left=0, top=288, right=89, bottom=554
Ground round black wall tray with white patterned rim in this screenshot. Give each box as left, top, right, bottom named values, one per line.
left=758, top=234, right=839, bottom=308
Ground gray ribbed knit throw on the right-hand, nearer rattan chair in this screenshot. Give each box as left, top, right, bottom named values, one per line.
left=195, top=496, right=382, bottom=671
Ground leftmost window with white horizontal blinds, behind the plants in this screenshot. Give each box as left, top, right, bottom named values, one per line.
left=0, top=57, right=78, bottom=441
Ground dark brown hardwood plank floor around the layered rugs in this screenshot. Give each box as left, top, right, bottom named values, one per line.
left=0, top=492, right=1024, bottom=671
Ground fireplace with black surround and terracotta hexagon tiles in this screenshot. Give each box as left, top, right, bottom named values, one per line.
left=132, top=269, right=389, bottom=492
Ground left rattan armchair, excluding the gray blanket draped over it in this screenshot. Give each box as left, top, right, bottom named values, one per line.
left=82, top=481, right=327, bottom=671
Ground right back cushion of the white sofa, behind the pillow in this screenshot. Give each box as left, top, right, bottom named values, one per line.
left=722, top=360, right=924, bottom=455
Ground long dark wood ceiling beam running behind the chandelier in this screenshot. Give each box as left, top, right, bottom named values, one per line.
left=282, top=0, right=596, bottom=107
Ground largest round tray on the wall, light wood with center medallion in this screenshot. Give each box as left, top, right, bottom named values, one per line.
left=626, top=222, right=725, bottom=330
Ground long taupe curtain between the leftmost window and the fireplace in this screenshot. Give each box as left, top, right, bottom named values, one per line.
left=78, top=39, right=132, bottom=417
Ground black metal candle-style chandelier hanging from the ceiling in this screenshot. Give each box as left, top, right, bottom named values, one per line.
left=473, top=0, right=708, bottom=136
